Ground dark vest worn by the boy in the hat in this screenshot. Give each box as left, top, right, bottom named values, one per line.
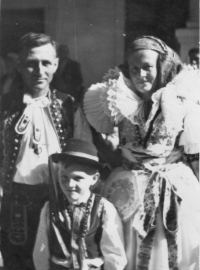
left=49, top=194, right=103, bottom=259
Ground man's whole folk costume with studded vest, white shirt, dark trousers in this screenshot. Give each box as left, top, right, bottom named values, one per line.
left=0, top=90, right=92, bottom=269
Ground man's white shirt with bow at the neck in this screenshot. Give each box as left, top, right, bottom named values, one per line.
left=13, top=94, right=92, bottom=185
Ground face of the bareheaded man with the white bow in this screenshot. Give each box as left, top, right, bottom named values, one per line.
left=19, top=44, right=58, bottom=97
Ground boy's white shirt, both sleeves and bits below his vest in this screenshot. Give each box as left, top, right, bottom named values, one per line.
left=33, top=196, right=127, bottom=270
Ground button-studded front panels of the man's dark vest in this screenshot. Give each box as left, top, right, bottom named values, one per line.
left=0, top=90, right=73, bottom=193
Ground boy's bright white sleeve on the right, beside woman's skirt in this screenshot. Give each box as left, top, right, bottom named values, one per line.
left=101, top=200, right=127, bottom=270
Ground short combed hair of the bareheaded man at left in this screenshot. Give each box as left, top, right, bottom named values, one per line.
left=18, top=33, right=57, bottom=55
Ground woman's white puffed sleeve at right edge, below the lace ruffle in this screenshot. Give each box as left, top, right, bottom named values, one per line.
left=179, top=101, right=200, bottom=154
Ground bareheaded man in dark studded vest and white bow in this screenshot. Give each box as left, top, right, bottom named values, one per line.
left=0, top=33, right=92, bottom=270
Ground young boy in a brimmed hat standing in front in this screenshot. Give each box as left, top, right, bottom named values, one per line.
left=33, top=139, right=126, bottom=270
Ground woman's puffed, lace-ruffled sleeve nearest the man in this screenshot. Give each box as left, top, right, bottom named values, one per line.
left=83, top=72, right=141, bottom=135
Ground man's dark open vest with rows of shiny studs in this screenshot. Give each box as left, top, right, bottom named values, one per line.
left=0, top=90, right=76, bottom=192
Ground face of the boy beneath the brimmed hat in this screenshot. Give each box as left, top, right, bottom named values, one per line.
left=59, top=162, right=99, bottom=204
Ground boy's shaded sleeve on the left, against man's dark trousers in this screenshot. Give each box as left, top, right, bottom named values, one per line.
left=33, top=202, right=50, bottom=270
